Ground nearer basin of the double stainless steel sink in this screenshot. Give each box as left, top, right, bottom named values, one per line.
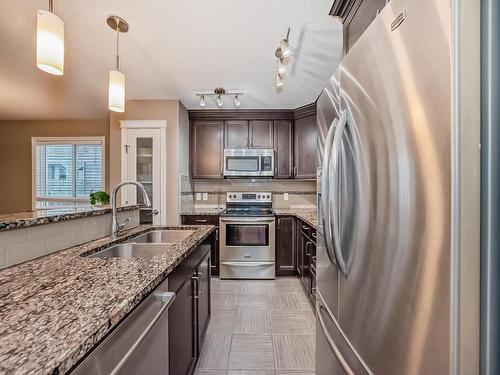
left=85, top=243, right=174, bottom=258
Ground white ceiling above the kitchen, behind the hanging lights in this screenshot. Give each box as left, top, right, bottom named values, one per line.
left=0, top=0, right=342, bottom=119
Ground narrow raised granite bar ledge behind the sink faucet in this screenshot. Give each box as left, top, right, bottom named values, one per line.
left=0, top=204, right=142, bottom=231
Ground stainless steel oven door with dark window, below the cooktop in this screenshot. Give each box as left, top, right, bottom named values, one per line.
left=220, top=217, right=275, bottom=262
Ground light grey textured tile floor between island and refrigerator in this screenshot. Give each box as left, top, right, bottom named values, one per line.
left=195, top=278, right=315, bottom=375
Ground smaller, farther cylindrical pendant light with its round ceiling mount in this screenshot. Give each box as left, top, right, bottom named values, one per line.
left=106, top=16, right=128, bottom=112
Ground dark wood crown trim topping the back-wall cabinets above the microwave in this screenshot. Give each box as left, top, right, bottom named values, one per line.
left=188, top=109, right=293, bottom=120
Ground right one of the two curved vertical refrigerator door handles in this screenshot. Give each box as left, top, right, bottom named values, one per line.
left=328, top=110, right=347, bottom=276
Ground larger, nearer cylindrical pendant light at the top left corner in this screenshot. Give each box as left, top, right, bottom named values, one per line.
left=36, top=0, right=64, bottom=76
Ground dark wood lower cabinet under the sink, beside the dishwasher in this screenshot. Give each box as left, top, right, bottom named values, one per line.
left=168, top=234, right=214, bottom=375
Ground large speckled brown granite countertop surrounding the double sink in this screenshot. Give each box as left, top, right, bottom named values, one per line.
left=0, top=225, right=214, bottom=375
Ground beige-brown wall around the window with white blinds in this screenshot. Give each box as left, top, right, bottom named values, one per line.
left=0, top=119, right=110, bottom=213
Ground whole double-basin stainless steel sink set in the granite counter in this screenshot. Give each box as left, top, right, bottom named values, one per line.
left=82, top=229, right=195, bottom=258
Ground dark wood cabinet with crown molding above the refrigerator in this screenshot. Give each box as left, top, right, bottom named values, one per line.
left=330, top=0, right=386, bottom=54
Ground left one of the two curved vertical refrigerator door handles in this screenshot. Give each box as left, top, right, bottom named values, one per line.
left=320, top=119, right=338, bottom=264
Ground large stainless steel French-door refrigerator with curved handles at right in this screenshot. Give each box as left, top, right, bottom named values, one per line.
left=316, top=0, right=452, bottom=375
